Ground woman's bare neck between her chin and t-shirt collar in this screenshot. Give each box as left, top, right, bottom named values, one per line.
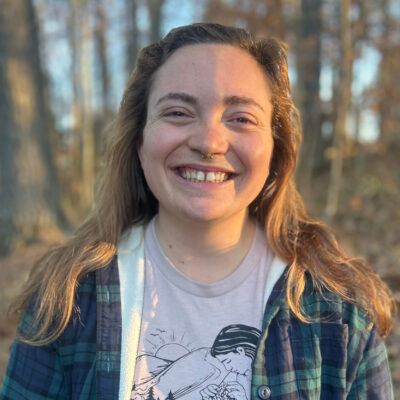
left=155, top=210, right=255, bottom=283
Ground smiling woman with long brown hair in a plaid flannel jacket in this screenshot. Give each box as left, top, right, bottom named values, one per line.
left=1, top=24, right=392, bottom=399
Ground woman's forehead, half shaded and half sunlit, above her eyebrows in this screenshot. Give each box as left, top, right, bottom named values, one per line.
left=149, top=44, right=270, bottom=104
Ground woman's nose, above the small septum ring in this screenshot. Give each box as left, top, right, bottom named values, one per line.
left=188, top=118, right=229, bottom=155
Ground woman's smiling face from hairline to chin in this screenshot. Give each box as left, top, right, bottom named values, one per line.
left=139, top=44, right=273, bottom=222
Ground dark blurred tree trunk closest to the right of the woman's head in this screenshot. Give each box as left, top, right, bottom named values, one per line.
left=296, top=0, right=322, bottom=197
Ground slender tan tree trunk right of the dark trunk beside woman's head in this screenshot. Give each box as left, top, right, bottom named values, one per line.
left=325, top=0, right=353, bottom=220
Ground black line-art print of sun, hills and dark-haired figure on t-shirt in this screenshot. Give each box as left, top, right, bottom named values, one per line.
left=131, top=324, right=261, bottom=400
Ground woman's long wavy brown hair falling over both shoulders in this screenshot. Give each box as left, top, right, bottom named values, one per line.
left=14, top=23, right=391, bottom=345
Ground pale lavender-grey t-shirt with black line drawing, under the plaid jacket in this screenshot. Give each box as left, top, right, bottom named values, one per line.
left=131, top=220, right=273, bottom=400
